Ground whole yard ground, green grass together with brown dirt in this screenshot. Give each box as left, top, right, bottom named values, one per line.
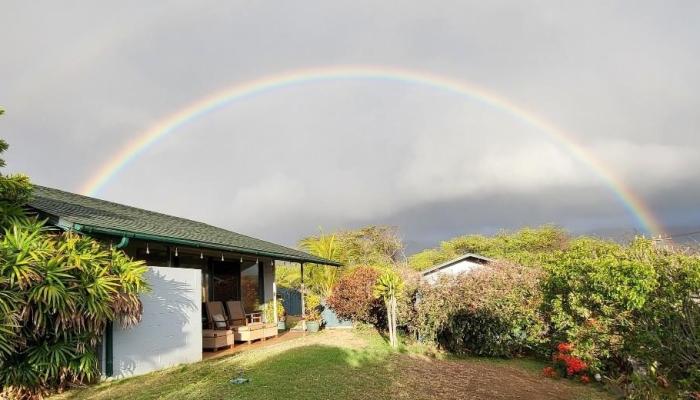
left=56, top=331, right=613, bottom=400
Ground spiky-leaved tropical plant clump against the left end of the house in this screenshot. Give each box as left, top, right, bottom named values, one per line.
left=0, top=137, right=147, bottom=398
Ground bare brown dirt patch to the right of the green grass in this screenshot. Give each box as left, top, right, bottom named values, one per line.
left=390, top=356, right=609, bottom=400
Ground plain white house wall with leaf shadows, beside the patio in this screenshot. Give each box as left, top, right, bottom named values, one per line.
left=113, top=267, right=201, bottom=377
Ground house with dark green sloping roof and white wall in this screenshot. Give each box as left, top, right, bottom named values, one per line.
left=28, top=186, right=339, bottom=377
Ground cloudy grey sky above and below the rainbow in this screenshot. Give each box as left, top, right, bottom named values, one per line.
left=0, top=1, right=700, bottom=250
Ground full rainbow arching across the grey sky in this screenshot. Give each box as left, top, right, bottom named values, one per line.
left=81, top=65, right=664, bottom=235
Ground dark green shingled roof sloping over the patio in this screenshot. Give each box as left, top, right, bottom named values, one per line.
left=29, top=185, right=340, bottom=265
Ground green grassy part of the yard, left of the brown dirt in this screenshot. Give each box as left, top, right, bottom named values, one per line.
left=58, top=345, right=390, bottom=400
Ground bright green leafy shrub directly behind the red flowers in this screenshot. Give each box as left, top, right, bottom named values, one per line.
left=543, top=238, right=656, bottom=371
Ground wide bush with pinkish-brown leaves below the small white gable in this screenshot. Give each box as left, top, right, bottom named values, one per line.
left=410, top=263, right=546, bottom=357
